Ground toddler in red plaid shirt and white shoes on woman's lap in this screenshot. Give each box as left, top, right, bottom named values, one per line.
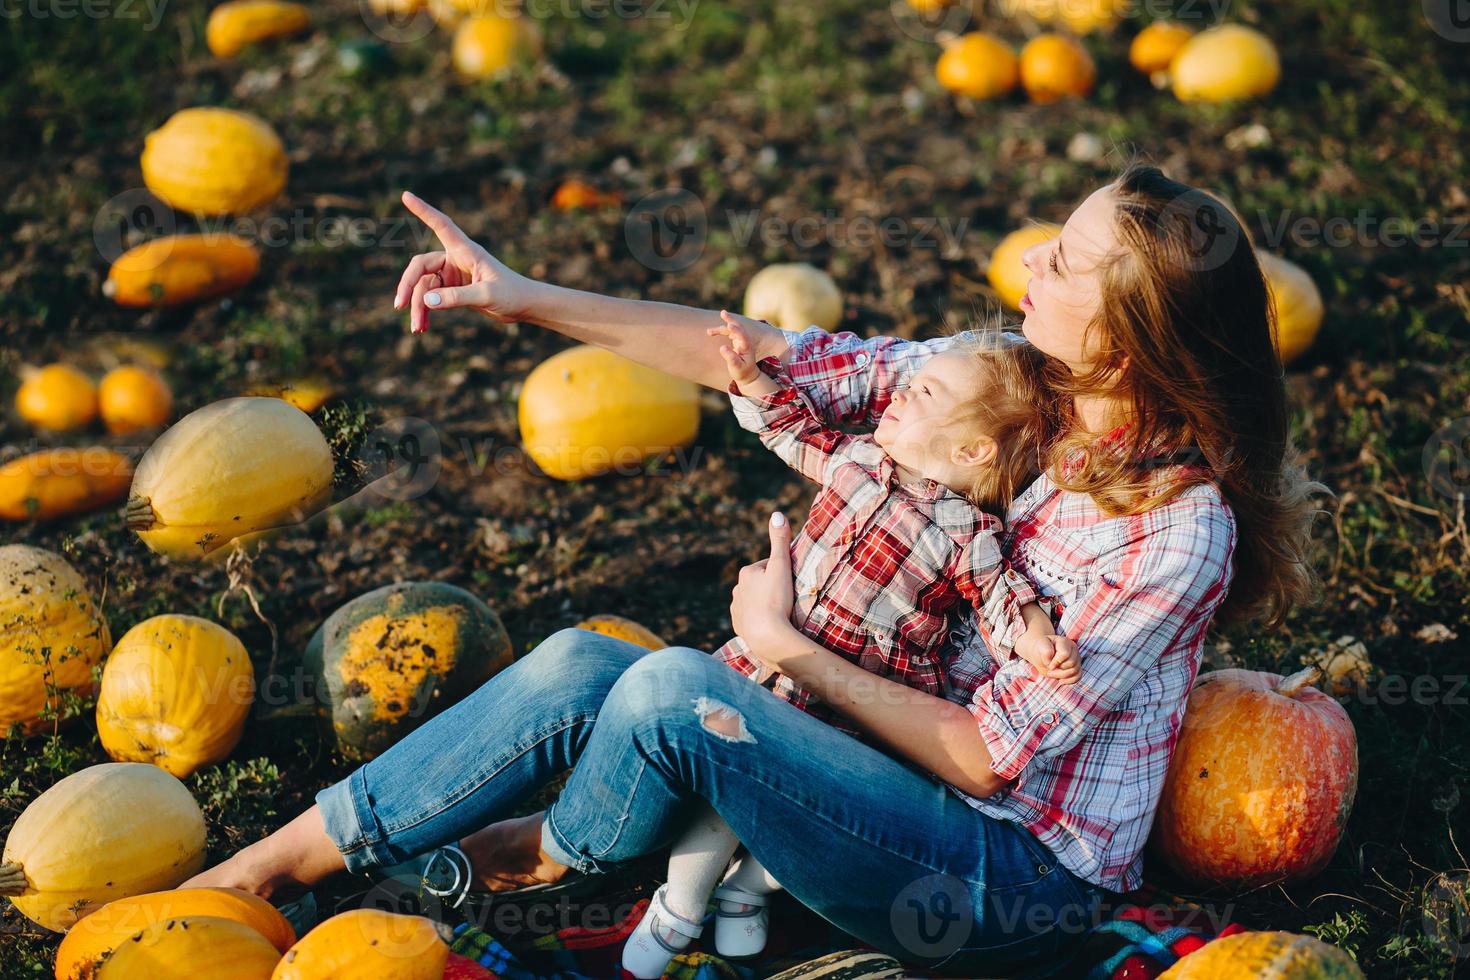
left=623, top=313, right=1080, bottom=979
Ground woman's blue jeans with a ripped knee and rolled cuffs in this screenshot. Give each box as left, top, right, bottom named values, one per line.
left=316, top=630, right=1104, bottom=976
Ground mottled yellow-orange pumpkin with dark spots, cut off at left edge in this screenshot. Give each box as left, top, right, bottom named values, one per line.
left=0, top=545, right=112, bottom=735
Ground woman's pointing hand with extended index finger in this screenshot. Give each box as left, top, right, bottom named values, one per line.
left=392, top=191, right=539, bottom=334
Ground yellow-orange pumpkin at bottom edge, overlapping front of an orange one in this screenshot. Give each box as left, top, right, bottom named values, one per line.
left=96, top=915, right=281, bottom=980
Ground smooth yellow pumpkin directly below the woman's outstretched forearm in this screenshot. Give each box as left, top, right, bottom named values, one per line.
left=520, top=347, right=700, bottom=480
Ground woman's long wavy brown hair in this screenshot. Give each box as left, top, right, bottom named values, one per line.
left=1050, top=163, right=1324, bottom=626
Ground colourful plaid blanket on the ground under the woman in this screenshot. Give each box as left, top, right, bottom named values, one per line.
left=445, top=886, right=1244, bottom=980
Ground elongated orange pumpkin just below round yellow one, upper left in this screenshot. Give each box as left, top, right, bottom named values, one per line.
left=101, top=235, right=260, bottom=307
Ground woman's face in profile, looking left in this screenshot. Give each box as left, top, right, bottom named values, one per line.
left=1020, top=185, right=1119, bottom=373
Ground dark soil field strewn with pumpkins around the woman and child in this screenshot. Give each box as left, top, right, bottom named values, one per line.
left=0, top=0, right=1470, bottom=980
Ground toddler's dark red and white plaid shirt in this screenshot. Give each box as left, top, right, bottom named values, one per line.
left=716, top=361, right=1035, bottom=732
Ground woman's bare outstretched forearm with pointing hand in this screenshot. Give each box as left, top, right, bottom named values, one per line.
left=392, top=191, right=786, bottom=389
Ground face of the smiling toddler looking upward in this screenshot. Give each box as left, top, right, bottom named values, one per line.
left=873, top=351, right=976, bottom=485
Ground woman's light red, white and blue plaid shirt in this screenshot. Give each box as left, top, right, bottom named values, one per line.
left=785, top=329, right=1236, bottom=890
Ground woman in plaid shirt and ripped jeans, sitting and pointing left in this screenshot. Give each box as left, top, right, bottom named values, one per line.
left=193, top=167, right=1311, bottom=976
